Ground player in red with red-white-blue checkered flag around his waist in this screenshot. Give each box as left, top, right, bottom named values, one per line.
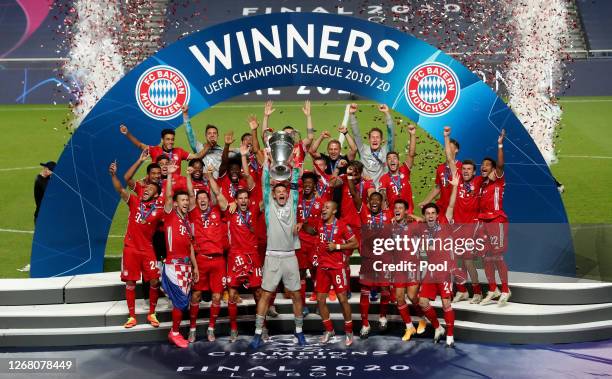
left=162, top=164, right=199, bottom=348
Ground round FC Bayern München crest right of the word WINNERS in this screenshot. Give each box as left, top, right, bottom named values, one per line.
left=404, top=62, right=460, bottom=117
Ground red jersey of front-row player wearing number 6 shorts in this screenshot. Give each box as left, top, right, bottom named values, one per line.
left=317, top=219, right=354, bottom=269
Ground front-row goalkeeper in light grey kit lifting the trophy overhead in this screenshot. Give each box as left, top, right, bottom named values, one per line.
left=249, top=151, right=306, bottom=349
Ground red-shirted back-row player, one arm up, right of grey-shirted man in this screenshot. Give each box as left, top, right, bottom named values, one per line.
left=378, top=124, right=416, bottom=213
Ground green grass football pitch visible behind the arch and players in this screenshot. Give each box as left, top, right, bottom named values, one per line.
left=0, top=97, right=612, bottom=278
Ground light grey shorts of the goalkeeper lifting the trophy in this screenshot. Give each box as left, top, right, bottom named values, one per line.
left=261, top=253, right=301, bottom=292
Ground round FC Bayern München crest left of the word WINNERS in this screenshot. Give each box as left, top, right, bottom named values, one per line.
left=136, top=66, right=189, bottom=121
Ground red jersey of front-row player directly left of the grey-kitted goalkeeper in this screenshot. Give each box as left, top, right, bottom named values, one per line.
left=225, top=201, right=261, bottom=254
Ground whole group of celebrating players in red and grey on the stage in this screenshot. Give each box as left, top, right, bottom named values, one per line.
left=109, top=101, right=510, bottom=348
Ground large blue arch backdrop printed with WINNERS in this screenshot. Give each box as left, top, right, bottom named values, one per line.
left=31, top=13, right=575, bottom=277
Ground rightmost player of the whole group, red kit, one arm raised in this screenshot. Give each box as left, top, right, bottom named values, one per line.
left=478, top=129, right=510, bottom=306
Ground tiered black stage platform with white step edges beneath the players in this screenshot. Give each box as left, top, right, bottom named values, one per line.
left=0, top=266, right=612, bottom=347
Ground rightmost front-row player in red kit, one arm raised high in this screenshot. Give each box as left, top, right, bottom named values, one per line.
left=419, top=175, right=459, bottom=347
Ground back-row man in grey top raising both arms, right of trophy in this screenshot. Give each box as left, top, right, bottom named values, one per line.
left=349, top=103, right=395, bottom=185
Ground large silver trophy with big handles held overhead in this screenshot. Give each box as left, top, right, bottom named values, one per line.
left=263, top=130, right=301, bottom=181
